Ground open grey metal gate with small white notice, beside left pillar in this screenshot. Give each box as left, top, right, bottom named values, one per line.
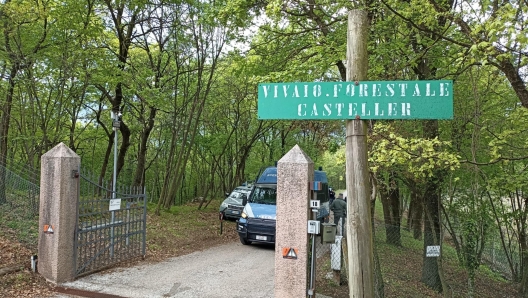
left=75, top=172, right=147, bottom=277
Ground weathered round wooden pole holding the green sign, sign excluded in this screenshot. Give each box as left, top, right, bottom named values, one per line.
left=345, top=10, right=374, bottom=297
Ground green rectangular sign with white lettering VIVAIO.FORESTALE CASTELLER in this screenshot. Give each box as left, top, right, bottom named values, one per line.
left=258, top=80, right=453, bottom=120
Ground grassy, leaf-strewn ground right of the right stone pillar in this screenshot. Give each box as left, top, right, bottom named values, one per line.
left=316, top=198, right=520, bottom=298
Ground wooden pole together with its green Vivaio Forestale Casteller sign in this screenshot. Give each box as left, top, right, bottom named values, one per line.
left=258, top=10, right=453, bottom=298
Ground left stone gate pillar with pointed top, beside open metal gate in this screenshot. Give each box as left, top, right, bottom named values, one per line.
left=37, top=143, right=81, bottom=284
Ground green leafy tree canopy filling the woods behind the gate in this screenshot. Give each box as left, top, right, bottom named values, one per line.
left=0, top=0, right=528, bottom=294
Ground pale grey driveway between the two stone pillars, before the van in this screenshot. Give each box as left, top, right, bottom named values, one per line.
left=57, top=242, right=275, bottom=298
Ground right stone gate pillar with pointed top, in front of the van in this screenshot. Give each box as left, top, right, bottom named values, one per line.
left=275, top=145, right=314, bottom=298
